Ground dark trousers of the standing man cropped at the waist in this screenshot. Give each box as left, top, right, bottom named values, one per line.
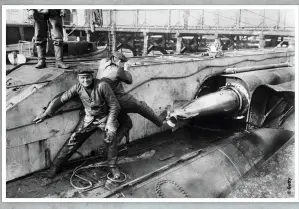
left=34, top=12, right=63, bottom=46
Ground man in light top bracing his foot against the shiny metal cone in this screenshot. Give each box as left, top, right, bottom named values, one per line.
left=97, top=52, right=167, bottom=134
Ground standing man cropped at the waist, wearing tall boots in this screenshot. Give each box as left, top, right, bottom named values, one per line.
left=28, top=9, right=69, bottom=69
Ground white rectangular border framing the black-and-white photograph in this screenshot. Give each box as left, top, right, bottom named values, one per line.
left=2, top=5, right=299, bottom=203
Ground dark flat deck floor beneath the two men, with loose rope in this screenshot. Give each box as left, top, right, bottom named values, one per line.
left=6, top=124, right=233, bottom=198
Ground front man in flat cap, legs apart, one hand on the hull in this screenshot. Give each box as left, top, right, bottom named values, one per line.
left=33, top=69, right=124, bottom=179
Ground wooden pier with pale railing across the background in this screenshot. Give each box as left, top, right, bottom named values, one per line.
left=7, top=9, right=295, bottom=56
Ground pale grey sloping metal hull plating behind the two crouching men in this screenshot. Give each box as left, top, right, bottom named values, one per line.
left=6, top=50, right=294, bottom=181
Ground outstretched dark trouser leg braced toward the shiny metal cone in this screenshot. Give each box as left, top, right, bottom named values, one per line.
left=115, top=94, right=163, bottom=127
